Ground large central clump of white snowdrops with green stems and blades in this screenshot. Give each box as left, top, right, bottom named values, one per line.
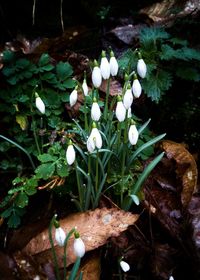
left=36, top=51, right=165, bottom=211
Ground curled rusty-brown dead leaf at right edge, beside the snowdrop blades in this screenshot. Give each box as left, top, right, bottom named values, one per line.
left=161, top=140, right=198, bottom=207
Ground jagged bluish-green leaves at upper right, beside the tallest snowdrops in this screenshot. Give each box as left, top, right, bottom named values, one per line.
left=119, top=27, right=200, bottom=103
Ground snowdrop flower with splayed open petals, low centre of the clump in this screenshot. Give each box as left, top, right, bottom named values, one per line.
left=87, top=123, right=102, bottom=153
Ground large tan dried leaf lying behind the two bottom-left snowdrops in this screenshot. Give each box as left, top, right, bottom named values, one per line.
left=23, top=208, right=138, bottom=267
